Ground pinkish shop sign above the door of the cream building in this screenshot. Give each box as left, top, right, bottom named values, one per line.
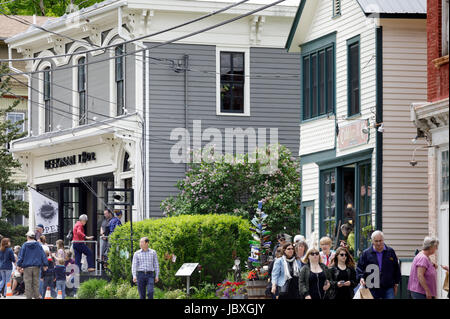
left=337, top=120, right=369, bottom=150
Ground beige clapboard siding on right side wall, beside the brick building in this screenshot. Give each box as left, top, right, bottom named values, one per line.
left=381, top=19, right=428, bottom=258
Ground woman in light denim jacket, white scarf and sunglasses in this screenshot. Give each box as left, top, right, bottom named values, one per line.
left=272, top=243, right=302, bottom=299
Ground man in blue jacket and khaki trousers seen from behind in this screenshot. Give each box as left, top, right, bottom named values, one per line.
left=17, top=231, right=48, bottom=299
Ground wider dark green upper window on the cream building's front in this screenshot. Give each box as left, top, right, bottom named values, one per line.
left=302, top=34, right=335, bottom=120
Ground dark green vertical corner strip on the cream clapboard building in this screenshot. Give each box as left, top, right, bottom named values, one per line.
left=375, top=26, right=383, bottom=230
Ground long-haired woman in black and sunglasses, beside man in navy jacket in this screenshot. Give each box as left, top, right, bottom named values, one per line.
left=330, top=247, right=357, bottom=300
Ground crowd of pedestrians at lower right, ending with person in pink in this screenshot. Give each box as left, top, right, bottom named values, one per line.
left=269, top=231, right=448, bottom=300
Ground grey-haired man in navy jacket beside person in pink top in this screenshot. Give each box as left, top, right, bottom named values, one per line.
left=356, top=230, right=401, bottom=299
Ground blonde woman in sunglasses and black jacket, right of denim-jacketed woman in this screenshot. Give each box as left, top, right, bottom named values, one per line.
left=299, top=248, right=332, bottom=299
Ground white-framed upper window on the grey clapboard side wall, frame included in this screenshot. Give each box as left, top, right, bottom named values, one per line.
left=216, top=47, right=250, bottom=116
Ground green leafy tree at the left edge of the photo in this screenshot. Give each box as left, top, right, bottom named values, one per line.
left=0, top=65, right=28, bottom=224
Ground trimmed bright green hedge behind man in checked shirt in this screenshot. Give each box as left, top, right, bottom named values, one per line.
left=108, top=215, right=251, bottom=289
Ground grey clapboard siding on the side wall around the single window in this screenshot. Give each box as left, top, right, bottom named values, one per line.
left=147, top=44, right=300, bottom=217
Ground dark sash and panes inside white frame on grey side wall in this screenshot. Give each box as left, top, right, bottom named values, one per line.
left=220, top=52, right=245, bottom=113
